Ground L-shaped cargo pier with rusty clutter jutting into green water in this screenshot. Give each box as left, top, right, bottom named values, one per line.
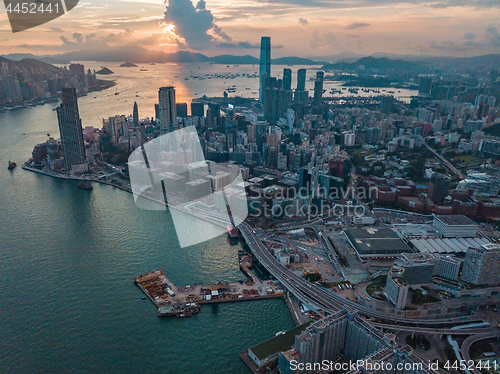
left=134, top=255, right=284, bottom=318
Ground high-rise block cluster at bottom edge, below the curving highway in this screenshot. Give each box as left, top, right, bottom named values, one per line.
left=274, top=311, right=432, bottom=374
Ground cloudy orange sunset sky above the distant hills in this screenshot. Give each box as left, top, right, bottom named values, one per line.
left=0, top=0, right=500, bottom=57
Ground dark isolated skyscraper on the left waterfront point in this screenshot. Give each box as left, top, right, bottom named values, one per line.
left=57, top=88, right=85, bottom=171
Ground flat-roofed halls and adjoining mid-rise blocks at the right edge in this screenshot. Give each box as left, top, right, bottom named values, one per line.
left=344, top=215, right=500, bottom=309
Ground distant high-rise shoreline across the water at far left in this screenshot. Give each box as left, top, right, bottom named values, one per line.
left=0, top=58, right=102, bottom=110
